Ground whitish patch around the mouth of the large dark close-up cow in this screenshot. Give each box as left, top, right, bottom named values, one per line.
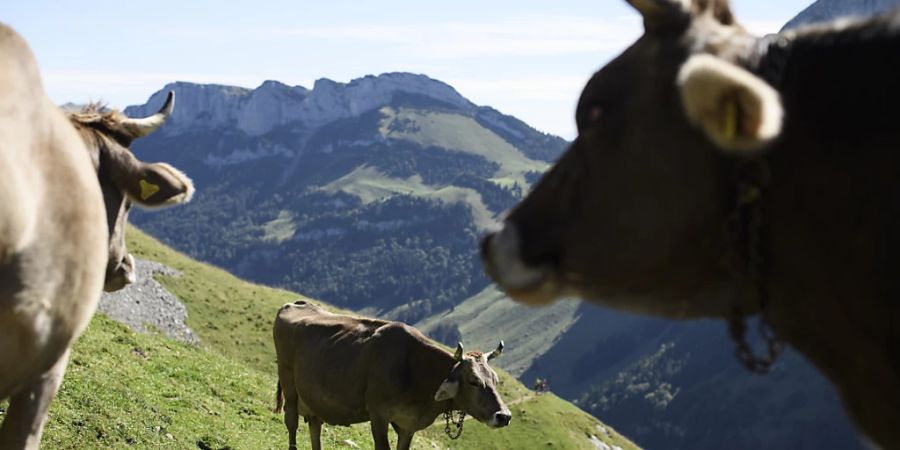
left=488, top=222, right=549, bottom=289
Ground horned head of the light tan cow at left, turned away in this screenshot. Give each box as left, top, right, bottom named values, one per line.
left=69, top=92, right=194, bottom=292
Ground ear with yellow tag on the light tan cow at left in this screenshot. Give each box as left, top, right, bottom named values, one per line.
left=123, top=163, right=194, bottom=208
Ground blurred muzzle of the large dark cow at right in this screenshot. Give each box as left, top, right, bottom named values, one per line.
left=481, top=222, right=561, bottom=305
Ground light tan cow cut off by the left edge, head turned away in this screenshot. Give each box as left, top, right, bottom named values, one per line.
left=0, top=24, right=193, bottom=450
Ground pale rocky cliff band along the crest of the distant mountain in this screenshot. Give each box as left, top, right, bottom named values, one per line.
left=125, top=73, right=475, bottom=136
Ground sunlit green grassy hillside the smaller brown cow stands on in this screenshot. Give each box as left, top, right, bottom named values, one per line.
left=33, top=231, right=635, bottom=449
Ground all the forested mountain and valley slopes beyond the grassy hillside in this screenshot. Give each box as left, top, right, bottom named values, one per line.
left=119, top=74, right=861, bottom=449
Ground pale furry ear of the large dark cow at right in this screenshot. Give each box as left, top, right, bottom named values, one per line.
left=678, top=54, right=784, bottom=154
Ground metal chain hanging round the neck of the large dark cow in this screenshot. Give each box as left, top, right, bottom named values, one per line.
left=728, top=157, right=784, bottom=375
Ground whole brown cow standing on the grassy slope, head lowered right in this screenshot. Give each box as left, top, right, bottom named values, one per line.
left=273, top=300, right=512, bottom=450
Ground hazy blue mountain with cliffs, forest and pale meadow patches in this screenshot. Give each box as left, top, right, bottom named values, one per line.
left=127, top=74, right=565, bottom=320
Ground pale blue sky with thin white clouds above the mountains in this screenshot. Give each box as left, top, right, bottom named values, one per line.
left=0, top=0, right=811, bottom=138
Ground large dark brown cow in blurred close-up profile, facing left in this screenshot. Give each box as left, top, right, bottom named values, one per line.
left=482, top=0, right=900, bottom=448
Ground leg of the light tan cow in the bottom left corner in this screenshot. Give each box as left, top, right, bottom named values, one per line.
left=0, top=350, right=69, bottom=450
